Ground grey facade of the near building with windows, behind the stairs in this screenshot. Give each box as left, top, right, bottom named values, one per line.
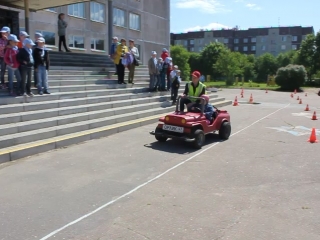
left=0, top=0, right=170, bottom=63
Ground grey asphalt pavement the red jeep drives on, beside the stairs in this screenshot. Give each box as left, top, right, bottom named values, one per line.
left=0, top=90, right=320, bottom=240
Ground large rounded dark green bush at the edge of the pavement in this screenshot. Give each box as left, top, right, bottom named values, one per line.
left=276, top=64, right=307, bottom=91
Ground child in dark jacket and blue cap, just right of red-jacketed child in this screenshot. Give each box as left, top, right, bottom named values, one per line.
left=17, top=38, right=35, bottom=97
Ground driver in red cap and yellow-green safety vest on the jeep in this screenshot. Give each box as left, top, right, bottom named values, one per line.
left=180, top=71, right=206, bottom=112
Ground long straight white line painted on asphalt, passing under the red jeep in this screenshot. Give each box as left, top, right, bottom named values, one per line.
left=40, top=103, right=290, bottom=240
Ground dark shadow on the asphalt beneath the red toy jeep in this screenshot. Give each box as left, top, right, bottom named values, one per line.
left=144, top=133, right=223, bottom=154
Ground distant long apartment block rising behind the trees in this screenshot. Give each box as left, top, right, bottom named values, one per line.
left=171, top=26, right=314, bottom=56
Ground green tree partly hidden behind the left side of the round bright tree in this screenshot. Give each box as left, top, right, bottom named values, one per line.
left=199, top=42, right=227, bottom=78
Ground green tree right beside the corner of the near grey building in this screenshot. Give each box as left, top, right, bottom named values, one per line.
left=170, top=45, right=190, bottom=81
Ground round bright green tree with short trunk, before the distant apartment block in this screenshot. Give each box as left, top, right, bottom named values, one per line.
left=213, top=50, right=245, bottom=86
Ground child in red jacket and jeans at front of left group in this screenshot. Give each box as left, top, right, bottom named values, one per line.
left=4, top=34, right=21, bottom=96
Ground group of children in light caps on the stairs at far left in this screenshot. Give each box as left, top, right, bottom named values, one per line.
left=0, top=27, right=50, bottom=97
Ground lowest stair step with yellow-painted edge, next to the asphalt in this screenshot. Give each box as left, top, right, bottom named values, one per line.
left=0, top=101, right=232, bottom=163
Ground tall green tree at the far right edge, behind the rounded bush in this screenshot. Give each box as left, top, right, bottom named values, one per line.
left=298, top=34, right=317, bottom=80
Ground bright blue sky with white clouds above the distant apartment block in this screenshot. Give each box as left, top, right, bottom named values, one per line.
left=170, top=0, right=320, bottom=33
